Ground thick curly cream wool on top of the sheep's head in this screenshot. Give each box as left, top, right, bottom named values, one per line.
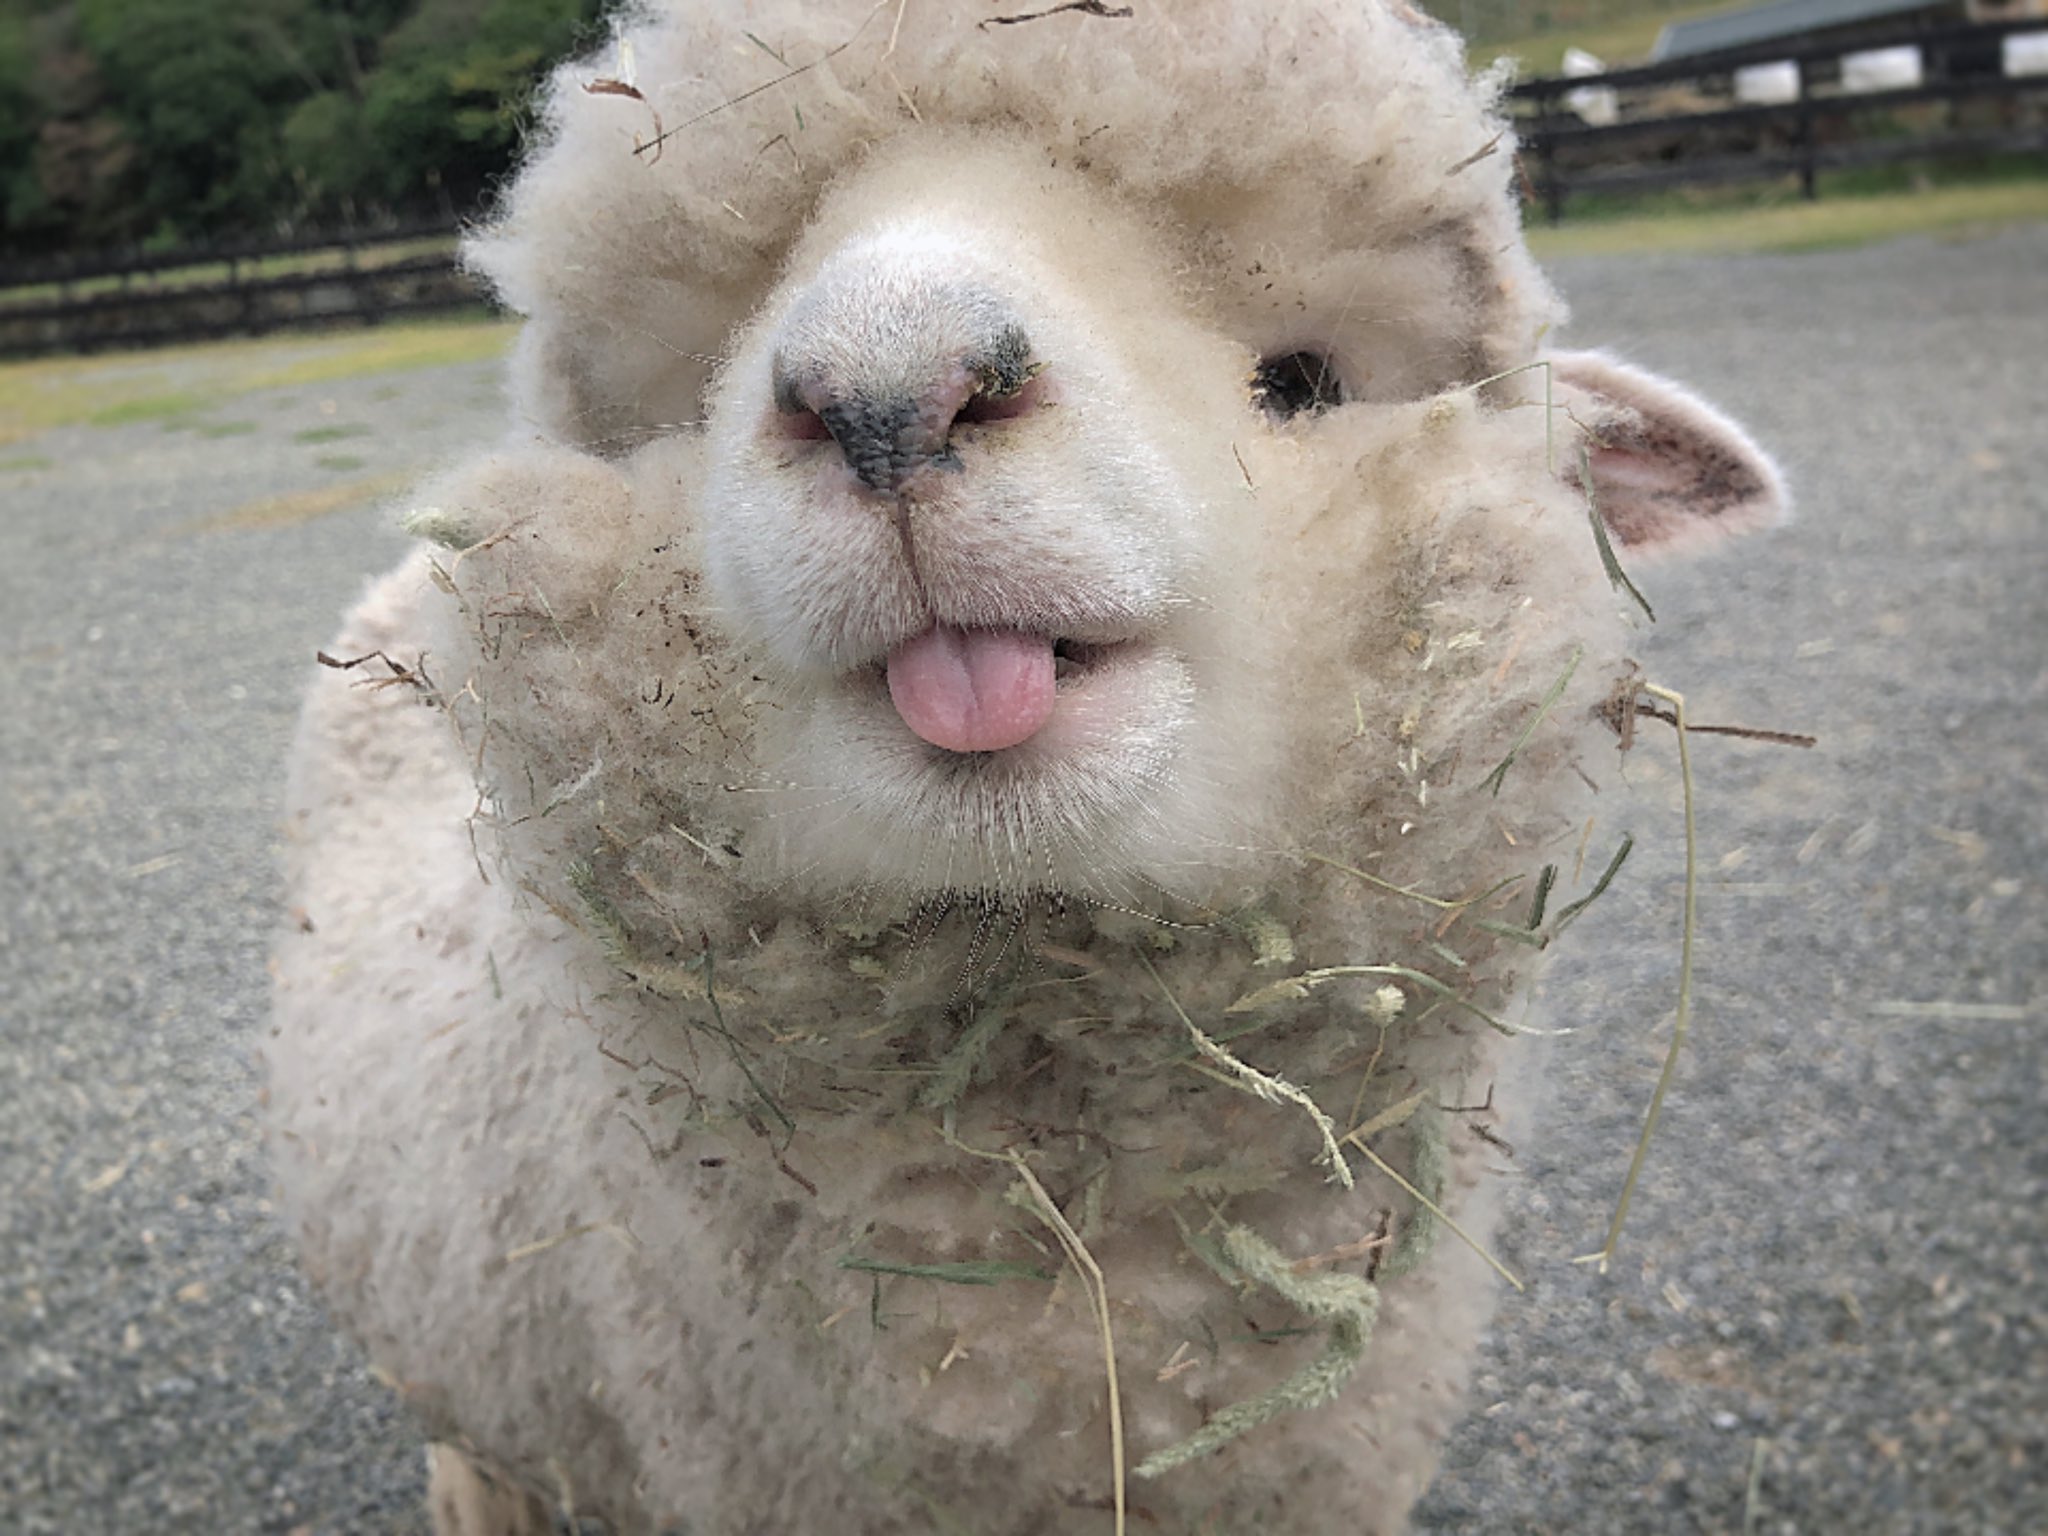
left=469, top=0, right=1563, bottom=449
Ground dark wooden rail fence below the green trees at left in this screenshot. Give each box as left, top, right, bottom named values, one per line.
left=0, top=223, right=485, bottom=356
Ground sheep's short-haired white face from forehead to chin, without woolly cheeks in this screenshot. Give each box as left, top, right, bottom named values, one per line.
left=702, top=139, right=1274, bottom=899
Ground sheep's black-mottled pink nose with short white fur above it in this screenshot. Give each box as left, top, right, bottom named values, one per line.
left=772, top=262, right=1040, bottom=496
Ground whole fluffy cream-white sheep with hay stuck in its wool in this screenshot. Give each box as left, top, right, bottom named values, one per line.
left=270, top=0, right=1782, bottom=1536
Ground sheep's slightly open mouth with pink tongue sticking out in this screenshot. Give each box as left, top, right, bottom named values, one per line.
left=868, top=625, right=1139, bottom=756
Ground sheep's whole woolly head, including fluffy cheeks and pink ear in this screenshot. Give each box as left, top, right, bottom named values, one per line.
left=444, top=0, right=1776, bottom=944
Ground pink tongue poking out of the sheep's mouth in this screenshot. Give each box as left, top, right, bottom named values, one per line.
left=889, top=625, right=1053, bottom=752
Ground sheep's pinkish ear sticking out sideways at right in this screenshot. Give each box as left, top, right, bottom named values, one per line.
left=1548, top=352, right=1790, bottom=555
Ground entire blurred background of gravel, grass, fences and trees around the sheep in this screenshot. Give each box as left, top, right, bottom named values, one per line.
left=0, top=0, right=2048, bottom=1536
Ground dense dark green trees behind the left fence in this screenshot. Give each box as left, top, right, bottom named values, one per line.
left=0, top=0, right=606, bottom=254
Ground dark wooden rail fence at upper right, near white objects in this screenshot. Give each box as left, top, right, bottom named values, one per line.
left=1513, top=20, right=2048, bottom=223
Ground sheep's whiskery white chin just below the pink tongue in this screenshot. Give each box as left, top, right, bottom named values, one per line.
left=760, top=641, right=1233, bottom=907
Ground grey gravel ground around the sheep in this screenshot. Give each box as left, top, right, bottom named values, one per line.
left=0, top=227, right=2048, bottom=1536
